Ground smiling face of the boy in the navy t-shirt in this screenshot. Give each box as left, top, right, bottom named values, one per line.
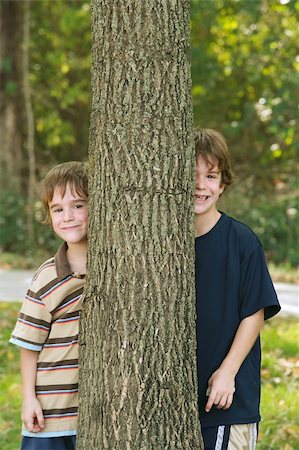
left=194, top=156, right=225, bottom=215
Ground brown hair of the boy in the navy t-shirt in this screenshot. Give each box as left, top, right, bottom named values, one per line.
left=194, top=128, right=235, bottom=186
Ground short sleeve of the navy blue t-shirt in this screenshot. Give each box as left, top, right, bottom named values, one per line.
left=240, top=241, right=280, bottom=320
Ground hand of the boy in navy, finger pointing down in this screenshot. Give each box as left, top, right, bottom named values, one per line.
left=205, top=367, right=235, bottom=412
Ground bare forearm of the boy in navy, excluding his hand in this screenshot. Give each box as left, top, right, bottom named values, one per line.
left=220, top=309, right=264, bottom=376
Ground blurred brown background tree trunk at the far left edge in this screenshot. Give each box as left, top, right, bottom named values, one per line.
left=0, top=0, right=23, bottom=191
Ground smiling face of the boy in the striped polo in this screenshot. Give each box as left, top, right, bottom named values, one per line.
left=49, top=185, right=88, bottom=244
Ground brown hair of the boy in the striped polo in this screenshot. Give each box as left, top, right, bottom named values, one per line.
left=41, top=161, right=88, bottom=224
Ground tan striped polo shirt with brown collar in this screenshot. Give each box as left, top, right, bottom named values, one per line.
left=10, top=243, right=85, bottom=437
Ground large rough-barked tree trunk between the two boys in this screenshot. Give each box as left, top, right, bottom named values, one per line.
left=77, top=0, right=202, bottom=450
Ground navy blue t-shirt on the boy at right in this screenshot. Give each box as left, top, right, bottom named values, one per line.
left=195, top=213, right=280, bottom=426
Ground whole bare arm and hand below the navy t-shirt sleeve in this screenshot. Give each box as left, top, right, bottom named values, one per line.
left=205, top=309, right=264, bottom=412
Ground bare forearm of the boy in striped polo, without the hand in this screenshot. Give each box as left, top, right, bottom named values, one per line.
left=20, top=348, right=39, bottom=399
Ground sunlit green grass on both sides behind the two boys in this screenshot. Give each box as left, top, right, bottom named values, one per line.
left=0, top=303, right=299, bottom=450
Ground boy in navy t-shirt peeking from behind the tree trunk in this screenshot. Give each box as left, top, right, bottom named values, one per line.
left=194, top=129, right=280, bottom=450
